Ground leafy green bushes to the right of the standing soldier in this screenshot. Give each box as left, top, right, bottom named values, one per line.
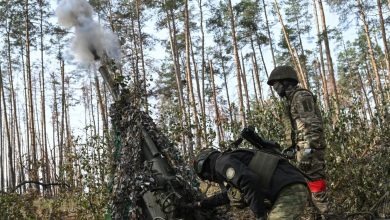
left=325, top=107, right=390, bottom=215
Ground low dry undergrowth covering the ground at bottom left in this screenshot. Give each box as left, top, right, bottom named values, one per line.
left=0, top=192, right=107, bottom=219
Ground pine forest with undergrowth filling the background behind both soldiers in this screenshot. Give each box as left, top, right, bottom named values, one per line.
left=0, top=0, right=390, bottom=219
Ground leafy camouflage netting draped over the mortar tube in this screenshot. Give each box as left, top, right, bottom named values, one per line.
left=106, top=87, right=229, bottom=219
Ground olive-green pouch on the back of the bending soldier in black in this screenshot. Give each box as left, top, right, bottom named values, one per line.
left=249, top=151, right=281, bottom=189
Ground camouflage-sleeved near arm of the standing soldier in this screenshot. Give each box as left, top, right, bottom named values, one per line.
left=291, top=91, right=323, bottom=148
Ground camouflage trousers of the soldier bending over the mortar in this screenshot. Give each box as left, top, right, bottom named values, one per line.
left=267, top=183, right=309, bottom=220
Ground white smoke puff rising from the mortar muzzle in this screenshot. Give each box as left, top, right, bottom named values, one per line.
left=56, top=0, right=120, bottom=63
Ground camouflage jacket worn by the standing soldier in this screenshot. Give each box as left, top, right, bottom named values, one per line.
left=284, top=86, right=326, bottom=149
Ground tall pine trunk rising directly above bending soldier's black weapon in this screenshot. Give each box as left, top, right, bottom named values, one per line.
left=228, top=0, right=246, bottom=127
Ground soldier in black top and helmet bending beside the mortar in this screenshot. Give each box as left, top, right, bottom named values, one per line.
left=192, top=148, right=309, bottom=220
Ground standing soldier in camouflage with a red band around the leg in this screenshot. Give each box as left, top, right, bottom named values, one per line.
left=267, top=66, right=328, bottom=217
